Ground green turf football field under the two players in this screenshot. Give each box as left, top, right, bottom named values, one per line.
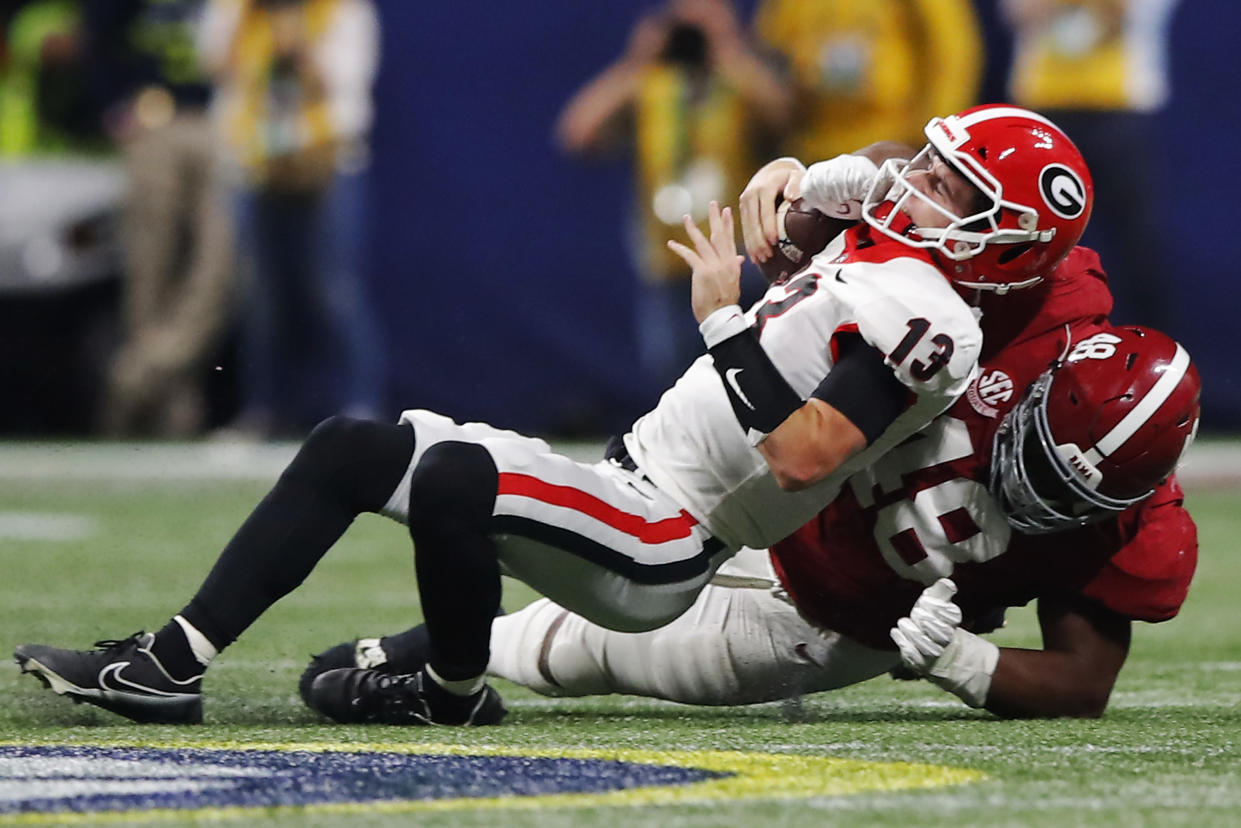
left=0, top=443, right=1241, bottom=828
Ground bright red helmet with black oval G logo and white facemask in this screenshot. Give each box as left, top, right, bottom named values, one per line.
left=862, top=104, right=1095, bottom=293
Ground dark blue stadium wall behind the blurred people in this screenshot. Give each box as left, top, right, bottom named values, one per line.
left=371, top=0, right=1241, bottom=433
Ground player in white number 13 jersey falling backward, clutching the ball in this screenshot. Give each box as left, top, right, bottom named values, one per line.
left=15, top=107, right=1091, bottom=725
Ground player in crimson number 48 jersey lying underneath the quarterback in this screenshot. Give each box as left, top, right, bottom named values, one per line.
left=292, top=248, right=1198, bottom=716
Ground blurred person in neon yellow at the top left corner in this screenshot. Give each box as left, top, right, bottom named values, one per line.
left=0, top=0, right=102, bottom=158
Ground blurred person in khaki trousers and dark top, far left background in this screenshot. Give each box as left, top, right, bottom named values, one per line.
left=83, top=0, right=233, bottom=437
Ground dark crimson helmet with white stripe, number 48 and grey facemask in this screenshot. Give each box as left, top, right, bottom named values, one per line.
left=990, top=328, right=1201, bottom=534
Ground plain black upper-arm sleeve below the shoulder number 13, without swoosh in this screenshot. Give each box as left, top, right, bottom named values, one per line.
left=810, top=334, right=910, bottom=446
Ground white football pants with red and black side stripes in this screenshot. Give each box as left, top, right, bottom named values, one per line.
left=381, top=410, right=732, bottom=632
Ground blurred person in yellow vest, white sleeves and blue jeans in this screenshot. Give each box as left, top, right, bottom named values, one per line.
left=201, top=0, right=386, bottom=437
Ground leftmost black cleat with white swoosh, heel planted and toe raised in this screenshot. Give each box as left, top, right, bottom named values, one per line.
left=12, top=632, right=202, bottom=725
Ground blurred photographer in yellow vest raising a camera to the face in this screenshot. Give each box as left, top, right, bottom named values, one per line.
left=557, top=0, right=791, bottom=402
